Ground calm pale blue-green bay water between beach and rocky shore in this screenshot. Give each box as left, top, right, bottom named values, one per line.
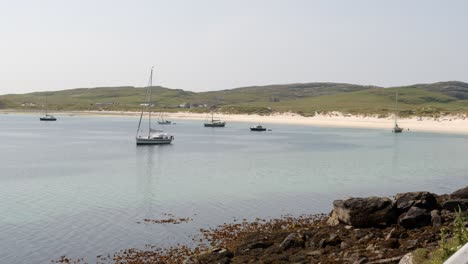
left=0, top=115, right=468, bottom=263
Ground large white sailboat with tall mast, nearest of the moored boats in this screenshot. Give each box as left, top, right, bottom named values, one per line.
left=136, top=68, right=174, bottom=145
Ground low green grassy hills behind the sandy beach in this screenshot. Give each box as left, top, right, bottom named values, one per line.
left=0, top=81, right=468, bottom=115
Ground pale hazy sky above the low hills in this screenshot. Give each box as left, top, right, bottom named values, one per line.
left=0, top=0, right=468, bottom=94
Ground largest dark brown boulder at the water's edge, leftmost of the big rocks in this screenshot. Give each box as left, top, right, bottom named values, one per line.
left=333, top=197, right=396, bottom=227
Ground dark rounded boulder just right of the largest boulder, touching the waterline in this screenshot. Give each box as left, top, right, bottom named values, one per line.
left=395, top=192, right=438, bottom=213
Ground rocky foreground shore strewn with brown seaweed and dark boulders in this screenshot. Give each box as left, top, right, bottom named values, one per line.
left=55, top=186, right=468, bottom=264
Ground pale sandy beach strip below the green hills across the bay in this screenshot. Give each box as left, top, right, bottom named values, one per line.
left=0, top=109, right=468, bottom=135
